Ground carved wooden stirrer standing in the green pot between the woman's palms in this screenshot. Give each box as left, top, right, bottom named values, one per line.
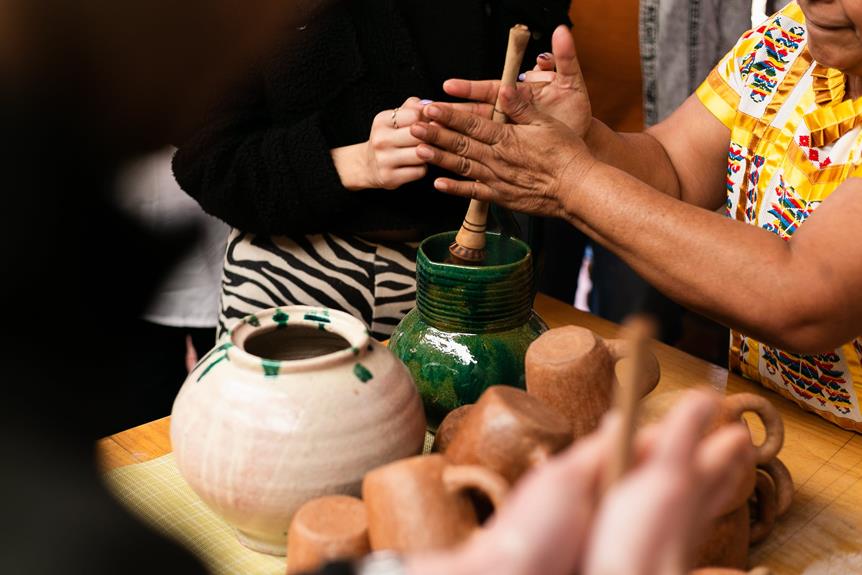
left=449, top=24, right=530, bottom=265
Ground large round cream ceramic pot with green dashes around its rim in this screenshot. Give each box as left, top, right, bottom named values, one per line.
left=171, top=306, right=425, bottom=555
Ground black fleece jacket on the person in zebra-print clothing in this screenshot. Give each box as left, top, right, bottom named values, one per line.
left=173, top=0, right=569, bottom=235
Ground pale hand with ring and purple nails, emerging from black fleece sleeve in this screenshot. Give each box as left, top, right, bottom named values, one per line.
left=332, top=98, right=428, bottom=191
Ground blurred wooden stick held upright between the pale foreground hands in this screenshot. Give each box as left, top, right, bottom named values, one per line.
left=605, top=320, right=651, bottom=488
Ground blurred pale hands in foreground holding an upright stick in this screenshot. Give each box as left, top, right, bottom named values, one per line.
left=408, top=392, right=754, bottom=575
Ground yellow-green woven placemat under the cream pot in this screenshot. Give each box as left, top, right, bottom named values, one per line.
left=105, top=434, right=434, bottom=575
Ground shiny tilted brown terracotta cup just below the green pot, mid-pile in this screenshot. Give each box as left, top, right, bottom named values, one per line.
left=446, top=385, right=572, bottom=484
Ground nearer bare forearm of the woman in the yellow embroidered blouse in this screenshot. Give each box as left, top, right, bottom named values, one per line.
left=563, top=163, right=846, bottom=352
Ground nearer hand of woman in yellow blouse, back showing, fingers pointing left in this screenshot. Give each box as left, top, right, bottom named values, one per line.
left=411, top=87, right=595, bottom=217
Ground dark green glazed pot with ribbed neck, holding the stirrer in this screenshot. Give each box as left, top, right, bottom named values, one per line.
left=389, top=232, right=548, bottom=428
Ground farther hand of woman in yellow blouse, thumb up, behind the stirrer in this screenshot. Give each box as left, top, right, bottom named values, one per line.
left=443, top=26, right=593, bottom=139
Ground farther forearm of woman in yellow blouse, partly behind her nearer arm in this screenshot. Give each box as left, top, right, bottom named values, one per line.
left=585, top=118, right=680, bottom=198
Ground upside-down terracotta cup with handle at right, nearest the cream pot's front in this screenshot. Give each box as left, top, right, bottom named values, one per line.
left=362, top=454, right=508, bottom=553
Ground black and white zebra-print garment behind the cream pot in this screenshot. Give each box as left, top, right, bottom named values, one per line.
left=218, top=229, right=419, bottom=339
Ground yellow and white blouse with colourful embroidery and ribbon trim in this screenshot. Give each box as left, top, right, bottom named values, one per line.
left=697, top=2, right=862, bottom=432
